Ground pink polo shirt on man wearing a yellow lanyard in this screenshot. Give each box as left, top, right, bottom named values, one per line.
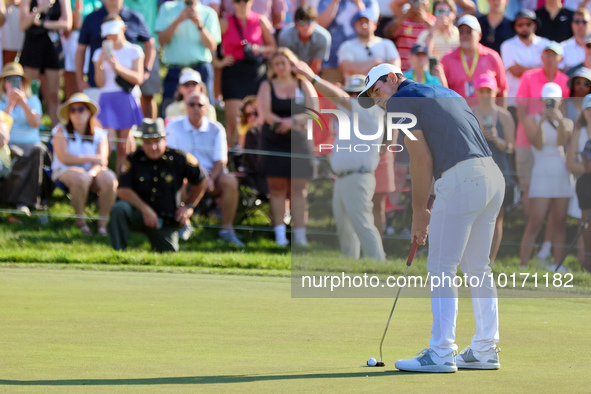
left=441, top=44, right=509, bottom=97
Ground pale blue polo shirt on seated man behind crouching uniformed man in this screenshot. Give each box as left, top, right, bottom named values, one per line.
left=166, top=115, right=228, bottom=173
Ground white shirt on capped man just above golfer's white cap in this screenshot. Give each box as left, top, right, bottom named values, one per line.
left=337, top=37, right=400, bottom=81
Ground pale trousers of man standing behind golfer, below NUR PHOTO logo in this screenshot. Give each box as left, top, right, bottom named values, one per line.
left=332, top=173, right=386, bottom=260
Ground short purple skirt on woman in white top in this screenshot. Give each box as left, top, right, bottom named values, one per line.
left=98, top=92, right=144, bottom=130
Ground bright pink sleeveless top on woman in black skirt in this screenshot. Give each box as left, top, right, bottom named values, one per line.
left=222, top=11, right=263, bottom=60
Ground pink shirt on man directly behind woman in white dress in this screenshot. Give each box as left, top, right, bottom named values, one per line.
left=515, top=67, right=570, bottom=148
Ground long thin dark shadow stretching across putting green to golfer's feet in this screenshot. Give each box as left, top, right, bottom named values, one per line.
left=0, top=370, right=414, bottom=386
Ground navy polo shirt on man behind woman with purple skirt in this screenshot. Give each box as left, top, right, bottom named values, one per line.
left=78, top=6, right=152, bottom=87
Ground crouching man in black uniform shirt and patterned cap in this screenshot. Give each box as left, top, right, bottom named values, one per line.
left=109, top=118, right=207, bottom=252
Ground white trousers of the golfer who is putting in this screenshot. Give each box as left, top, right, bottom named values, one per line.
left=427, top=157, right=505, bottom=357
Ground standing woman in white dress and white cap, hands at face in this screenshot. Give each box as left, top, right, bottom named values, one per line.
left=520, top=82, right=573, bottom=267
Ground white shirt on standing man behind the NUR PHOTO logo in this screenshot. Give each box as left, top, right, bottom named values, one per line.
left=330, top=100, right=386, bottom=174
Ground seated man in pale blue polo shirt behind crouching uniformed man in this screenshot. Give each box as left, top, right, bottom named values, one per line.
left=166, top=93, right=244, bottom=246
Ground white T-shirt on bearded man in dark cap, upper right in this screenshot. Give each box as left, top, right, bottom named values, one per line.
left=501, top=36, right=550, bottom=106
